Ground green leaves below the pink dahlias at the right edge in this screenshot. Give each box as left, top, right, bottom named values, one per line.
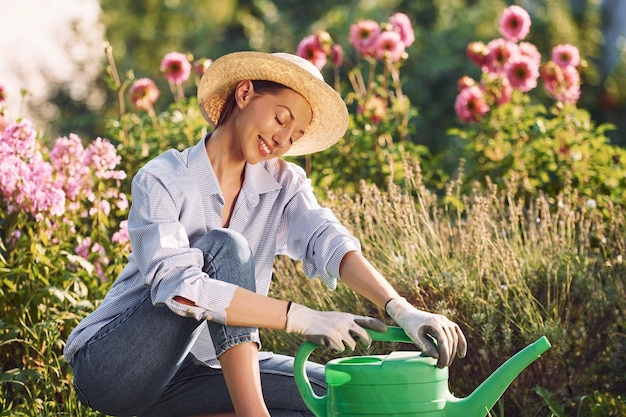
left=450, top=92, right=626, bottom=202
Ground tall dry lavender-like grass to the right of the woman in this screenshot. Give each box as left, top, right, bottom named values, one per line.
left=265, top=160, right=626, bottom=416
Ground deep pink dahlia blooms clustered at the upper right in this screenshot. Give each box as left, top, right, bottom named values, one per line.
left=454, top=6, right=580, bottom=122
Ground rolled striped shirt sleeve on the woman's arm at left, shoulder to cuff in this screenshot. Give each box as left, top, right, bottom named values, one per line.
left=128, top=171, right=236, bottom=324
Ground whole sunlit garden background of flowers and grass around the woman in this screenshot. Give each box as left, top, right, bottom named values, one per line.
left=0, top=0, right=626, bottom=417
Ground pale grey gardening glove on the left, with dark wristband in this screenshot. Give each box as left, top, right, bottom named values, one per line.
left=285, top=303, right=387, bottom=352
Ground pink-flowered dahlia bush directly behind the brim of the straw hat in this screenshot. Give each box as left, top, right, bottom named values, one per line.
left=296, top=13, right=428, bottom=190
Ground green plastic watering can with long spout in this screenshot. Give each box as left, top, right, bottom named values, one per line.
left=294, top=327, right=550, bottom=417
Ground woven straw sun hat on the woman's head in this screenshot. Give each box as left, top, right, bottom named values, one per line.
left=198, top=52, right=348, bottom=156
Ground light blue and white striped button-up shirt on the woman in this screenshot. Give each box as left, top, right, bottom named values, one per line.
left=64, top=138, right=360, bottom=365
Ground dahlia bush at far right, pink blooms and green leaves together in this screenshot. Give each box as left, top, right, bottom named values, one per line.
left=449, top=6, right=626, bottom=202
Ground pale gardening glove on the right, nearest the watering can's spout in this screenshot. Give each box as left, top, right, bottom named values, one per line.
left=385, top=297, right=467, bottom=368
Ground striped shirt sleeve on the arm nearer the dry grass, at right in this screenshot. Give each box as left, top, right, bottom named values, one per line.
left=283, top=172, right=361, bottom=290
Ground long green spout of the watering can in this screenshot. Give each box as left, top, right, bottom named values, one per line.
left=446, top=336, right=551, bottom=417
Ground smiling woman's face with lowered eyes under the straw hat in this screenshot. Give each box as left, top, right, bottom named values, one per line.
left=235, top=82, right=312, bottom=164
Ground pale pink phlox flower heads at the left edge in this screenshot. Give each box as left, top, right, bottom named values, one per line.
left=0, top=115, right=128, bottom=220
